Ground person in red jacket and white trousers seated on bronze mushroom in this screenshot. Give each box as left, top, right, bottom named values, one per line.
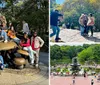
left=20, top=33, right=36, bottom=65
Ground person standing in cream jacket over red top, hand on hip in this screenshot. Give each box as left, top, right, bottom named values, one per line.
left=31, top=32, right=44, bottom=67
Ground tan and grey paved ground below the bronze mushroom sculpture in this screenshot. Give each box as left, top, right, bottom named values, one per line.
left=0, top=52, right=49, bottom=85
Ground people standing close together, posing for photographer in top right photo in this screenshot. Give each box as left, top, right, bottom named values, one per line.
left=79, top=13, right=95, bottom=36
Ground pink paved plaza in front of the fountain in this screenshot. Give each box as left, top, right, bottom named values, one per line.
left=50, top=76, right=100, bottom=85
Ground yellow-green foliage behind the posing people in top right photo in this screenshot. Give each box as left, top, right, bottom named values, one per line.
left=52, top=0, right=100, bottom=31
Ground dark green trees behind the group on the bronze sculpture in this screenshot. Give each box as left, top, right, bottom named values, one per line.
left=1, top=0, right=49, bottom=50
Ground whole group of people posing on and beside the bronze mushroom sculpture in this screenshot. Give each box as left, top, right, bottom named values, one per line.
left=0, top=16, right=44, bottom=69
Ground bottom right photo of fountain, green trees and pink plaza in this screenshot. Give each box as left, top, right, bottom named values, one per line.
left=50, top=44, right=100, bottom=85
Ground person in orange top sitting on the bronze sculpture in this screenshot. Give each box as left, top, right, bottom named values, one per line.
left=8, top=26, right=20, bottom=44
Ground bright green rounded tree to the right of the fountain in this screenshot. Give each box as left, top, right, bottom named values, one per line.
left=78, top=45, right=100, bottom=64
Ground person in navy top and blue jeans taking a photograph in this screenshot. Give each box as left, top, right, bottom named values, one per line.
left=50, top=10, right=63, bottom=42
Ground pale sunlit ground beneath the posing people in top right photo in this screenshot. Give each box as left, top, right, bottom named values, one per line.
left=50, top=29, right=100, bottom=43
